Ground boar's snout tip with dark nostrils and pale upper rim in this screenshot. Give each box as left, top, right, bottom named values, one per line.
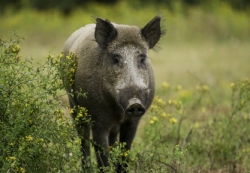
left=125, top=98, right=146, bottom=117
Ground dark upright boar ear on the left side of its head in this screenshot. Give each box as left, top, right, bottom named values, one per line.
left=95, top=18, right=117, bottom=49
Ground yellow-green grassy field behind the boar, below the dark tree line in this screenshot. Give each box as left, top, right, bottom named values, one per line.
left=0, top=1, right=250, bottom=173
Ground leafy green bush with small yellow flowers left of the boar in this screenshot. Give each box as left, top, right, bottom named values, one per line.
left=0, top=34, right=80, bottom=173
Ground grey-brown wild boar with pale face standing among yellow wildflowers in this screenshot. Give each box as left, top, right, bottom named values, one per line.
left=63, top=16, right=163, bottom=172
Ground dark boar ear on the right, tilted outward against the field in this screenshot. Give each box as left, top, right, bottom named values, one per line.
left=141, top=16, right=163, bottom=49
